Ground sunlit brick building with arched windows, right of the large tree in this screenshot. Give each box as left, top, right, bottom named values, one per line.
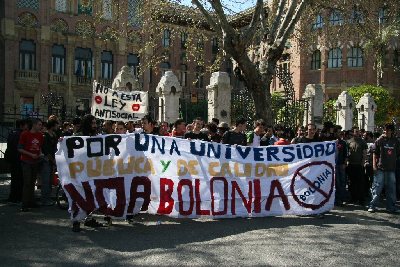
left=271, top=6, right=400, bottom=100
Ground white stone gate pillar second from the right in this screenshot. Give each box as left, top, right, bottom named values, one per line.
left=335, top=91, right=354, bottom=131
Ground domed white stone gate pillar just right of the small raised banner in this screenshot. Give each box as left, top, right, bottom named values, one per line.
left=156, top=71, right=182, bottom=123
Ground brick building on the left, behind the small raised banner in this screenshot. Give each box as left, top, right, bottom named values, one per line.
left=0, top=0, right=222, bottom=121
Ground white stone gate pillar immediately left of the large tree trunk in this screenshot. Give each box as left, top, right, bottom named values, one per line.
left=207, top=72, right=232, bottom=123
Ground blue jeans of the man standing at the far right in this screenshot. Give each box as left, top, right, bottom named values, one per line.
left=369, top=170, right=396, bottom=211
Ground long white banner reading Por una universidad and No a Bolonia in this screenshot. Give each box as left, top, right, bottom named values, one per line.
left=56, top=133, right=336, bottom=221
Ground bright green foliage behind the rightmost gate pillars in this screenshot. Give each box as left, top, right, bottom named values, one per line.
left=347, top=85, right=398, bottom=126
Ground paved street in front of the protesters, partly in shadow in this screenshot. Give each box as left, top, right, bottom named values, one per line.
left=0, top=180, right=400, bottom=266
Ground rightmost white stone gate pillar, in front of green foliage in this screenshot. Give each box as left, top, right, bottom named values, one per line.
left=356, top=93, right=376, bottom=132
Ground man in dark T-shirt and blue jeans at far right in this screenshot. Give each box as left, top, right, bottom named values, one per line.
left=368, top=123, right=400, bottom=213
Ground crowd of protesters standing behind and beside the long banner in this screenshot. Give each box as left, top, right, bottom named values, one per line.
left=5, top=114, right=400, bottom=231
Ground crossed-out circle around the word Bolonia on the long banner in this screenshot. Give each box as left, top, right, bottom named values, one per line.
left=290, top=161, right=335, bottom=210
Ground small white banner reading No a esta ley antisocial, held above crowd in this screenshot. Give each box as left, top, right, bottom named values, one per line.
left=92, top=81, right=148, bottom=122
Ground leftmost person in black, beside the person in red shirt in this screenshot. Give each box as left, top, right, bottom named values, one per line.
left=4, top=119, right=28, bottom=204
